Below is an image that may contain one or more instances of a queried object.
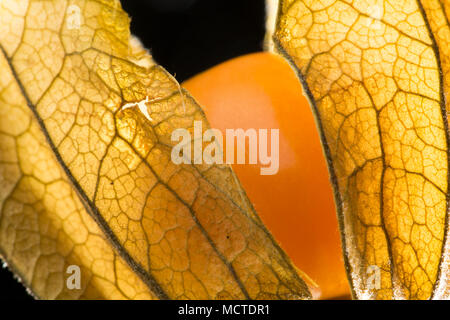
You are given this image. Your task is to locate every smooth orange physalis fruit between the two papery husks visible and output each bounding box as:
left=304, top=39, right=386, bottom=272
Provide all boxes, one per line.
left=182, top=53, right=350, bottom=299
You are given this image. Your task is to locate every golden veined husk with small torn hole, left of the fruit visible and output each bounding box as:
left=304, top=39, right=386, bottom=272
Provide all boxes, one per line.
left=0, top=0, right=310, bottom=299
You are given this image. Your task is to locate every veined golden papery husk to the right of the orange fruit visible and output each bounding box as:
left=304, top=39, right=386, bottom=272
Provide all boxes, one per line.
left=273, top=0, right=449, bottom=299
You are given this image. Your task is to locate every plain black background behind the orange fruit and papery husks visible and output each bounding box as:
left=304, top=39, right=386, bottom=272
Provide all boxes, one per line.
left=0, top=0, right=265, bottom=299
